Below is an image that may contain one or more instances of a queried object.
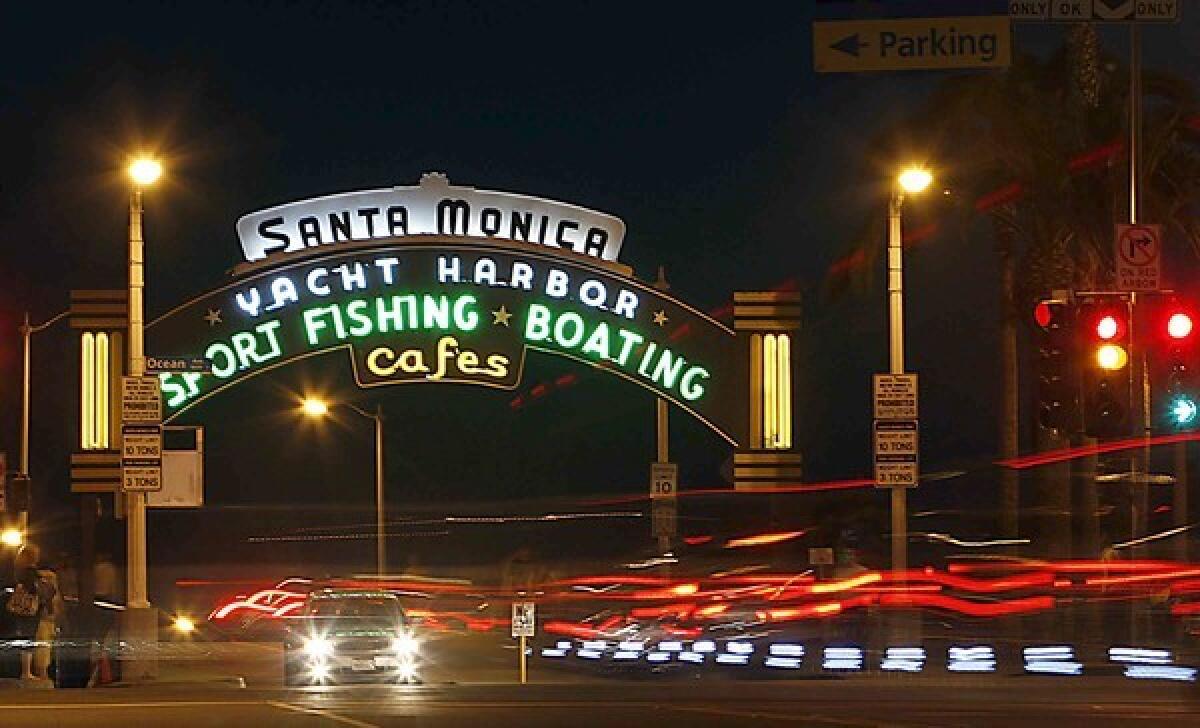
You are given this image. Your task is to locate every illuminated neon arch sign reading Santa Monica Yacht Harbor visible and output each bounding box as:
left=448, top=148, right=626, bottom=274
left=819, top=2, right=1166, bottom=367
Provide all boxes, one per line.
left=146, top=175, right=748, bottom=445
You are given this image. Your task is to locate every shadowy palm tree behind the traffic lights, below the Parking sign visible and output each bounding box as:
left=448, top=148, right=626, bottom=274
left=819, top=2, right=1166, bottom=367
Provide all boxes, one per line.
left=827, top=25, right=1200, bottom=555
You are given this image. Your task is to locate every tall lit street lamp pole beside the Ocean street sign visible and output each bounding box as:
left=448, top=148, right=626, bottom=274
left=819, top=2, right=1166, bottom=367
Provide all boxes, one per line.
left=125, top=158, right=162, bottom=609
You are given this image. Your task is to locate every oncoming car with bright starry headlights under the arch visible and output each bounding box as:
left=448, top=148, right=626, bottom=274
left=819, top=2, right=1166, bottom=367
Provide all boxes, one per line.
left=283, top=589, right=420, bottom=686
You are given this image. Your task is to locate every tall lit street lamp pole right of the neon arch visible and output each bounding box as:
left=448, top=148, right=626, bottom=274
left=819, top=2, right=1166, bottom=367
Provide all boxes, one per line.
left=888, top=167, right=934, bottom=571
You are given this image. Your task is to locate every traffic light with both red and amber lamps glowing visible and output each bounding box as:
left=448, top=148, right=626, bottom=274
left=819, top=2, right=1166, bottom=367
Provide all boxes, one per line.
left=1076, top=299, right=1133, bottom=438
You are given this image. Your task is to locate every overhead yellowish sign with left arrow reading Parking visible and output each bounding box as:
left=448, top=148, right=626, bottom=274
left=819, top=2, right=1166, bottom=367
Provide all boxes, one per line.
left=812, top=16, right=1013, bottom=73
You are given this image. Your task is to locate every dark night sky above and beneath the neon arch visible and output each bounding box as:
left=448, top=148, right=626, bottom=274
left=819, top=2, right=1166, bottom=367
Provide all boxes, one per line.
left=0, top=1, right=1200, bottom=570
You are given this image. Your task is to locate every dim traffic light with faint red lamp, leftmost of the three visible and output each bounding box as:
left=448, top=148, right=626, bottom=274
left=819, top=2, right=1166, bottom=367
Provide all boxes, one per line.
left=1033, top=300, right=1079, bottom=433
